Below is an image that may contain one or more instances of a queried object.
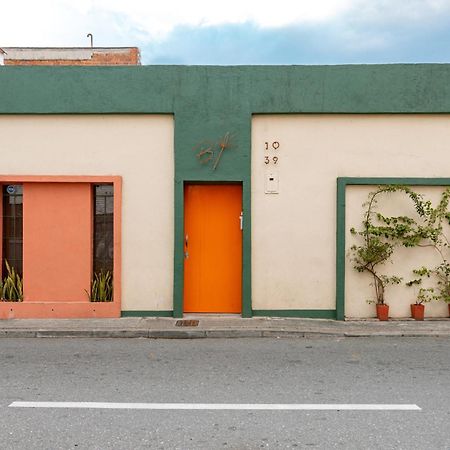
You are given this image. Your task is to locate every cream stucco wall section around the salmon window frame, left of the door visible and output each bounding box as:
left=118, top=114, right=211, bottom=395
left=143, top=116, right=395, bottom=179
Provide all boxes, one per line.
left=0, top=115, right=174, bottom=310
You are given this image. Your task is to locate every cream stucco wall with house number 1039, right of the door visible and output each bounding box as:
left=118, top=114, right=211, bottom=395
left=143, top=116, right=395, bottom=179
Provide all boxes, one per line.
left=252, top=115, right=450, bottom=317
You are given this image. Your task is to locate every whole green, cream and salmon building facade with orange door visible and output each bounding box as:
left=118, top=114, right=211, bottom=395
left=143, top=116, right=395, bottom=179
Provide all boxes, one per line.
left=0, top=65, right=450, bottom=319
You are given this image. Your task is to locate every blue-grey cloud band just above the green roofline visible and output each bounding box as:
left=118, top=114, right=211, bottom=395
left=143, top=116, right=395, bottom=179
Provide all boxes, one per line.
left=142, top=11, right=450, bottom=65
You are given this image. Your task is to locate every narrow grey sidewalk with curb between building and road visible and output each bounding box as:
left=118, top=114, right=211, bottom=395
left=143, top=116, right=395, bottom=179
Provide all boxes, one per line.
left=0, top=315, right=450, bottom=339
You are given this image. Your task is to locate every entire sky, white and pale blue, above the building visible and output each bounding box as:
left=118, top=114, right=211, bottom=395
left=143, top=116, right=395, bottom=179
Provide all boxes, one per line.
left=0, top=0, right=450, bottom=64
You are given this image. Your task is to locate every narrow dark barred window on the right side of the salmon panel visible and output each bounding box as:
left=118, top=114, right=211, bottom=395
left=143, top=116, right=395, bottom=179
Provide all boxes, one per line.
left=93, top=184, right=114, bottom=273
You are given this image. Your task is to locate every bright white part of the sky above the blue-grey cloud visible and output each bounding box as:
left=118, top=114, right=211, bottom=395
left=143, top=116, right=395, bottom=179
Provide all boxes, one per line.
left=0, top=0, right=374, bottom=46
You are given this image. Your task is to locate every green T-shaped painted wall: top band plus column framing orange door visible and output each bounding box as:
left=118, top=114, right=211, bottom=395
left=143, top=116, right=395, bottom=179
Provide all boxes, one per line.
left=0, top=64, right=450, bottom=318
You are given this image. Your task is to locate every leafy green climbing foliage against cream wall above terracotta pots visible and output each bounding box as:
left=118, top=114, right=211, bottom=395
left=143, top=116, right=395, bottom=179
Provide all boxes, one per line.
left=350, top=185, right=450, bottom=303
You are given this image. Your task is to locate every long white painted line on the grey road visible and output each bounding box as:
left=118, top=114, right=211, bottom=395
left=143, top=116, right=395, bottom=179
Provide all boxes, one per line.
left=9, top=402, right=422, bottom=411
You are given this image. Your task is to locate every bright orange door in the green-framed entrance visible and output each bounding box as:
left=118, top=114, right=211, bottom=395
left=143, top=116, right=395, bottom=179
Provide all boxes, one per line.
left=184, top=184, right=242, bottom=313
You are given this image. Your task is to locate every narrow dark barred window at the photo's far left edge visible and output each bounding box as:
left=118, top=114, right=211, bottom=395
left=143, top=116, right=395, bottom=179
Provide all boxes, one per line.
left=2, top=184, right=23, bottom=277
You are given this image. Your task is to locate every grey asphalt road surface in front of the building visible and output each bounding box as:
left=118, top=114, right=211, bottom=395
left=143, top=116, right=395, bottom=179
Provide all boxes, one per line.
left=0, top=337, right=450, bottom=449
